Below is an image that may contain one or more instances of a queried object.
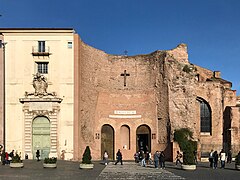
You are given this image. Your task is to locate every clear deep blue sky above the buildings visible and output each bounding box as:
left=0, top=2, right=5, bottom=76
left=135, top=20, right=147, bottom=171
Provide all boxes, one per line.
left=0, top=0, right=240, bottom=95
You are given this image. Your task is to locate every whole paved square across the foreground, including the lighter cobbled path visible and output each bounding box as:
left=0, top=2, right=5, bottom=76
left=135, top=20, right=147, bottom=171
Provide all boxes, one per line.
left=0, top=160, right=240, bottom=180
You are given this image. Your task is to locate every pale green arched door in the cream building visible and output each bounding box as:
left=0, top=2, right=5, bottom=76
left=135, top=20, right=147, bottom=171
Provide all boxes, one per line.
left=32, top=116, right=51, bottom=159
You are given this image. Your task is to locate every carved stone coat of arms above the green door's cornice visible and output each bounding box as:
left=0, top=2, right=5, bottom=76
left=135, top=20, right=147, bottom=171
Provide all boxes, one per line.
left=25, top=73, right=57, bottom=98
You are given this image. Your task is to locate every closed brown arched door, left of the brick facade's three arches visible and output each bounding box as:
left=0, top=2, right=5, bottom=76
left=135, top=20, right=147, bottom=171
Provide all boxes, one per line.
left=101, top=124, right=114, bottom=160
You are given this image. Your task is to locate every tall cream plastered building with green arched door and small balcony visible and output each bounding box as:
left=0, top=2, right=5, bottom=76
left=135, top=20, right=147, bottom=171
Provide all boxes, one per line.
left=0, top=28, right=75, bottom=159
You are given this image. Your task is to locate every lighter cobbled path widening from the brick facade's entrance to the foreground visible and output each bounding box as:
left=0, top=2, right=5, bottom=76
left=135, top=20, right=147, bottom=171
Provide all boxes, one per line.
left=97, top=162, right=185, bottom=180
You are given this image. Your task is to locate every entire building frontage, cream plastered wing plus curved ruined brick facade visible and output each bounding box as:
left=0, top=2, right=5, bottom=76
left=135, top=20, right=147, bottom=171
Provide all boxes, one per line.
left=0, top=29, right=240, bottom=160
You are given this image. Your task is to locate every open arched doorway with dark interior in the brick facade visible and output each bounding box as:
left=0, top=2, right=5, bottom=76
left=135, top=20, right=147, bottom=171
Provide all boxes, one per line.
left=136, top=125, right=151, bottom=152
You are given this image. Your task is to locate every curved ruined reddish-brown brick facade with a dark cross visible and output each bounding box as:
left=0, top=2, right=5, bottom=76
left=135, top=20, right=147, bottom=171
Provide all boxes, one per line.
left=76, top=40, right=239, bottom=159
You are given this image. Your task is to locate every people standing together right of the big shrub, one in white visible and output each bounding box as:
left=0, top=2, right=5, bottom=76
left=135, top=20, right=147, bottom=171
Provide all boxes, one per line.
left=209, top=149, right=232, bottom=169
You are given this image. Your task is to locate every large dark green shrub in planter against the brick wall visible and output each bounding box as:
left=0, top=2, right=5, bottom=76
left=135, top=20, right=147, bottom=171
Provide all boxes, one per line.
left=174, top=128, right=197, bottom=165
